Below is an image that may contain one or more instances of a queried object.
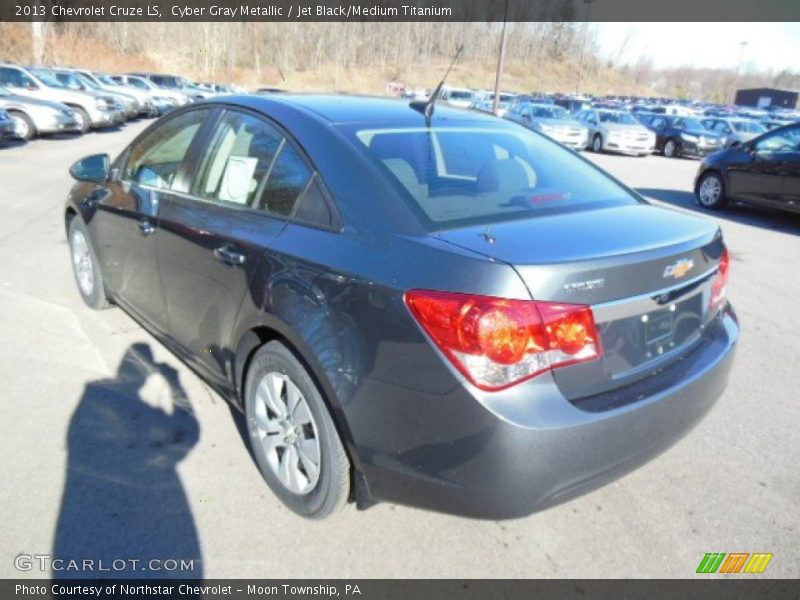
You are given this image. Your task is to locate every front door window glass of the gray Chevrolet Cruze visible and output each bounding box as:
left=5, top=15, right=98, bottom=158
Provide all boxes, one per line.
left=122, top=110, right=209, bottom=189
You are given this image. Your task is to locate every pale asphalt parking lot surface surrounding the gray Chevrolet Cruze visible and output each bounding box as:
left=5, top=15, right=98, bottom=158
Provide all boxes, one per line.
left=0, top=122, right=800, bottom=578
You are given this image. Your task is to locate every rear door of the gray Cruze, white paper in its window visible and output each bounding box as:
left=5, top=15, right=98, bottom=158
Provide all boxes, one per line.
left=159, top=110, right=330, bottom=387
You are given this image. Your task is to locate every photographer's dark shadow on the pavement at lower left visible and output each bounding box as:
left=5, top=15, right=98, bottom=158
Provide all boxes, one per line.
left=52, top=343, right=203, bottom=580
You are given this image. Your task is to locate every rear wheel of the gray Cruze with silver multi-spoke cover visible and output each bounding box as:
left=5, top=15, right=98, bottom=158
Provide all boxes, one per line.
left=245, top=341, right=350, bottom=519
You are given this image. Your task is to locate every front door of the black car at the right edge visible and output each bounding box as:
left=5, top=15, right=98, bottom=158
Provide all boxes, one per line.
left=728, top=126, right=792, bottom=205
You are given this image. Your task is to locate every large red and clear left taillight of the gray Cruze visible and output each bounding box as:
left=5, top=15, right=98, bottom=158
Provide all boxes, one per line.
left=405, top=290, right=602, bottom=390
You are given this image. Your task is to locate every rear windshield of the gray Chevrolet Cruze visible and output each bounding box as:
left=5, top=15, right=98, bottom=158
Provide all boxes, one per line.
left=349, top=125, right=639, bottom=230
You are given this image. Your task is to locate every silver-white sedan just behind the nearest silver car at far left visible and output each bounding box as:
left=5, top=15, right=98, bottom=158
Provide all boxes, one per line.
left=0, top=63, right=122, bottom=133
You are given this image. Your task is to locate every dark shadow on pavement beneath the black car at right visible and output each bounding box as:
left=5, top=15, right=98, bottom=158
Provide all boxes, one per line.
left=636, top=188, right=800, bottom=235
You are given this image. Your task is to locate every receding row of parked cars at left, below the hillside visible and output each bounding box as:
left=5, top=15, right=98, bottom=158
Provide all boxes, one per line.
left=0, top=63, right=242, bottom=140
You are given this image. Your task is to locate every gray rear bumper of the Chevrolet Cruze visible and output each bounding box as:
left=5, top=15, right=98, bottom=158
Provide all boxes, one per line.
left=356, top=307, right=739, bottom=519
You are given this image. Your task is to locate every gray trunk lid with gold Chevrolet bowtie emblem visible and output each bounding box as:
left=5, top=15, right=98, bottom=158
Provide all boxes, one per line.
left=438, top=204, right=724, bottom=399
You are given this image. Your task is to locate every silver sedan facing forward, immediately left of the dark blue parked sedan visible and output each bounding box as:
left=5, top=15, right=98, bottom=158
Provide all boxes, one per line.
left=577, top=108, right=656, bottom=156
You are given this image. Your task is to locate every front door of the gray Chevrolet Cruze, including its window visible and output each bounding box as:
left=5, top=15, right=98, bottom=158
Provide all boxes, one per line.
left=90, top=110, right=211, bottom=333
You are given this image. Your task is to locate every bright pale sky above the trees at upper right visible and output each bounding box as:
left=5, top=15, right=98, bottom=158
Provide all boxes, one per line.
left=589, top=23, right=800, bottom=71
